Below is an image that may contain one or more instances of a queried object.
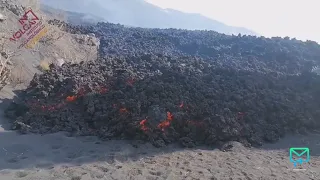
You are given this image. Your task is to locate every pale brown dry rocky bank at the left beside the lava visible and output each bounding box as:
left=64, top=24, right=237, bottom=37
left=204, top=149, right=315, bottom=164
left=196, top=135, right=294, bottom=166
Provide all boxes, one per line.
left=0, top=0, right=97, bottom=85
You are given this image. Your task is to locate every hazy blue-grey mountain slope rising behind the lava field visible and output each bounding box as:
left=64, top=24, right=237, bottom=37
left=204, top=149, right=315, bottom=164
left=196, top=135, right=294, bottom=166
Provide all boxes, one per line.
left=41, top=0, right=258, bottom=35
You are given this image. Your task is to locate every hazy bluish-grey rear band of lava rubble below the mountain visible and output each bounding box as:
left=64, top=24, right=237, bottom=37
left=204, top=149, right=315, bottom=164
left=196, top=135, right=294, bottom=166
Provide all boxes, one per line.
left=82, top=23, right=320, bottom=74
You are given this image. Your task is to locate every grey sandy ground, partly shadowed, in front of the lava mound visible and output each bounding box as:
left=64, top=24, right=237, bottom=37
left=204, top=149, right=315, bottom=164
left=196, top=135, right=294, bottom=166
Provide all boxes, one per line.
left=0, top=88, right=320, bottom=180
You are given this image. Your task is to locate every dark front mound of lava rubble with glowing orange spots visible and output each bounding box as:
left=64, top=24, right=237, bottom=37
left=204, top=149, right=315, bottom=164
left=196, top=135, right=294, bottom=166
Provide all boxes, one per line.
left=6, top=55, right=320, bottom=147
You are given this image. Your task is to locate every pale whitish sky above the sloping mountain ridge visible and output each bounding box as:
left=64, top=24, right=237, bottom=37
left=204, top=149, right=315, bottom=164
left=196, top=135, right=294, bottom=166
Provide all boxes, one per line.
left=146, top=0, right=320, bottom=42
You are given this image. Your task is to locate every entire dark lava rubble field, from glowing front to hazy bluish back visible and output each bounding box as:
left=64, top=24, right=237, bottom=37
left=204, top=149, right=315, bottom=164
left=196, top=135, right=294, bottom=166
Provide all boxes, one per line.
left=6, top=22, right=320, bottom=146
